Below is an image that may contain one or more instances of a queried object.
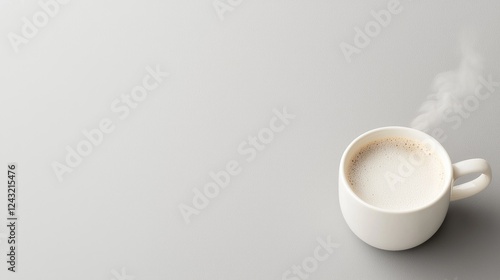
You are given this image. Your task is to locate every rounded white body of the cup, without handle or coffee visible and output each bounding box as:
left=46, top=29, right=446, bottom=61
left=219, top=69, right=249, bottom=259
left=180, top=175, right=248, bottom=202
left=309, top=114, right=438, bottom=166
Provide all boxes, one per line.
left=339, top=127, right=453, bottom=250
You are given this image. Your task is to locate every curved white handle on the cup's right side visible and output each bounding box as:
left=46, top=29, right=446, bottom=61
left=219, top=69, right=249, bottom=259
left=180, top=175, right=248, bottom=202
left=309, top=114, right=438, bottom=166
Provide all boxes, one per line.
left=450, top=158, right=491, bottom=201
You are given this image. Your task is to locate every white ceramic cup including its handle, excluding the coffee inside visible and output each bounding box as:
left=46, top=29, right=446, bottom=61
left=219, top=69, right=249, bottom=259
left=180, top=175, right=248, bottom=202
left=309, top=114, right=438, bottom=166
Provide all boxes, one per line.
left=339, top=127, right=491, bottom=250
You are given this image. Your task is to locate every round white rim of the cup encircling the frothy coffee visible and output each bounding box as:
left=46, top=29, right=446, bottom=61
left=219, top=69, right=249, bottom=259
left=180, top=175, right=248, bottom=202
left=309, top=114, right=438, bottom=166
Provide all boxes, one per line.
left=339, top=126, right=453, bottom=214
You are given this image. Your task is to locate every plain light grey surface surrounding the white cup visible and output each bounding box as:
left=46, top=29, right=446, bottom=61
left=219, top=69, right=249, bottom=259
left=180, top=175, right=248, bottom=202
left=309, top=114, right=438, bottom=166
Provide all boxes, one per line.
left=0, top=0, right=500, bottom=280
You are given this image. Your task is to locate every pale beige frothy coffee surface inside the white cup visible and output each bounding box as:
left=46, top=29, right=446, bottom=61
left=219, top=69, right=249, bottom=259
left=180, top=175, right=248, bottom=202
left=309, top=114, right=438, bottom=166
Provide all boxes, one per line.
left=346, top=137, right=445, bottom=210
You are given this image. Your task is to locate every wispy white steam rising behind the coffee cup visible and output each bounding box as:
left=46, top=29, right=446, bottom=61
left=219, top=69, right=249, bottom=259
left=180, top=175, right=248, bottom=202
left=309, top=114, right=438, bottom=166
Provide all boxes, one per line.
left=411, top=32, right=483, bottom=131
